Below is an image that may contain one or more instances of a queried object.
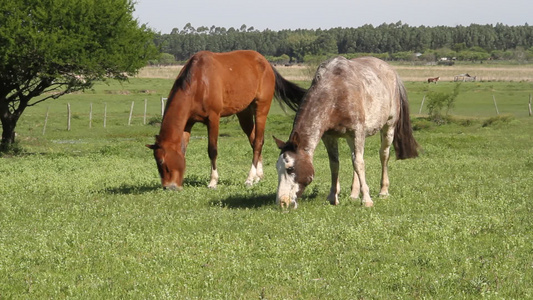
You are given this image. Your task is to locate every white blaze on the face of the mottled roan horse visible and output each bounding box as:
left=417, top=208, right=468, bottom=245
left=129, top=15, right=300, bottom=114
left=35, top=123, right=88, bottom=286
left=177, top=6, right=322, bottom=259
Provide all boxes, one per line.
left=276, top=152, right=299, bottom=208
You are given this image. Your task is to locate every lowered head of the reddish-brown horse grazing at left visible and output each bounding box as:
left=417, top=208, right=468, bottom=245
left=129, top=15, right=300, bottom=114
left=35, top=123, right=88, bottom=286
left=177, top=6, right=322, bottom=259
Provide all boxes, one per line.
left=146, top=136, right=185, bottom=190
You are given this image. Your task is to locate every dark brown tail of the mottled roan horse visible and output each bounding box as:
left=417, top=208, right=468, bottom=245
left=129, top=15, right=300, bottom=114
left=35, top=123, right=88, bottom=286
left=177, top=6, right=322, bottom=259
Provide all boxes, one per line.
left=393, top=77, right=419, bottom=159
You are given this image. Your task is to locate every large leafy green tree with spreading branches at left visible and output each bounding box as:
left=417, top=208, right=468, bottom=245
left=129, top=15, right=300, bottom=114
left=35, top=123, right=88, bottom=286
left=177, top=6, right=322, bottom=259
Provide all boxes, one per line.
left=0, top=0, right=157, bottom=150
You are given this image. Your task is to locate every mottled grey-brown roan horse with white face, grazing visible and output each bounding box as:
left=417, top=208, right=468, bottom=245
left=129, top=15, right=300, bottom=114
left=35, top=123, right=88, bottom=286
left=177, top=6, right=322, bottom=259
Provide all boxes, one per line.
left=274, top=57, right=418, bottom=207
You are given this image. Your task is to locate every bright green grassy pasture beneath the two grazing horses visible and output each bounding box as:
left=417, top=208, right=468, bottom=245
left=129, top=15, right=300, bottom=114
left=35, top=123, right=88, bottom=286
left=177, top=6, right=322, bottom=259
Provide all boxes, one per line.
left=0, top=67, right=533, bottom=299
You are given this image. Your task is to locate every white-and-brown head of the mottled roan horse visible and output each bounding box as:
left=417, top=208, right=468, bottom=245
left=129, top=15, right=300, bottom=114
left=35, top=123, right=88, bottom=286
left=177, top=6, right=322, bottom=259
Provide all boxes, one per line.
left=274, top=137, right=315, bottom=208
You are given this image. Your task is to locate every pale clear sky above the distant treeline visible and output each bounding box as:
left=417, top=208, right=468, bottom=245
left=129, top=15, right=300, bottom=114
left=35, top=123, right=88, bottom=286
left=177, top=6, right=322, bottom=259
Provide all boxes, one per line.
left=134, top=0, right=533, bottom=33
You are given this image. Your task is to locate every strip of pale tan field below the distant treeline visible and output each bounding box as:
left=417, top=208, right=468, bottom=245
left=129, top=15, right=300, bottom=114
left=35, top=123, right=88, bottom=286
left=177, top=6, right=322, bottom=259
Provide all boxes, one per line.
left=137, top=63, right=533, bottom=81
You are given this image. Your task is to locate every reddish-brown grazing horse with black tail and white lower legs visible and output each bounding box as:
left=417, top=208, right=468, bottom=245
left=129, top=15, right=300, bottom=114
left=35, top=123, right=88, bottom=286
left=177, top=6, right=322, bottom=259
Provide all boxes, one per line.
left=146, top=51, right=306, bottom=190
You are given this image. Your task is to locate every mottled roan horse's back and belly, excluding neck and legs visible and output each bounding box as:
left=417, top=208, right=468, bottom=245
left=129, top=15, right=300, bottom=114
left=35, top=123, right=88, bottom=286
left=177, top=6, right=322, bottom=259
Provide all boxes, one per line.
left=315, top=57, right=399, bottom=135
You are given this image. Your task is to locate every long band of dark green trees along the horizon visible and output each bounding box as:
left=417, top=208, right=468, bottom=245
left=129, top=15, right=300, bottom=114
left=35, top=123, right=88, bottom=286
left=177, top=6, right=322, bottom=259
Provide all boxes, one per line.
left=153, top=21, right=533, bottom=64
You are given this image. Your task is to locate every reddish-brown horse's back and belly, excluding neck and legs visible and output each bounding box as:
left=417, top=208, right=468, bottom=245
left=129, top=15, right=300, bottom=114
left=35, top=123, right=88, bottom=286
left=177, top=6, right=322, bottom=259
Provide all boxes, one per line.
left=169, top=50, right=275, bottom=119
